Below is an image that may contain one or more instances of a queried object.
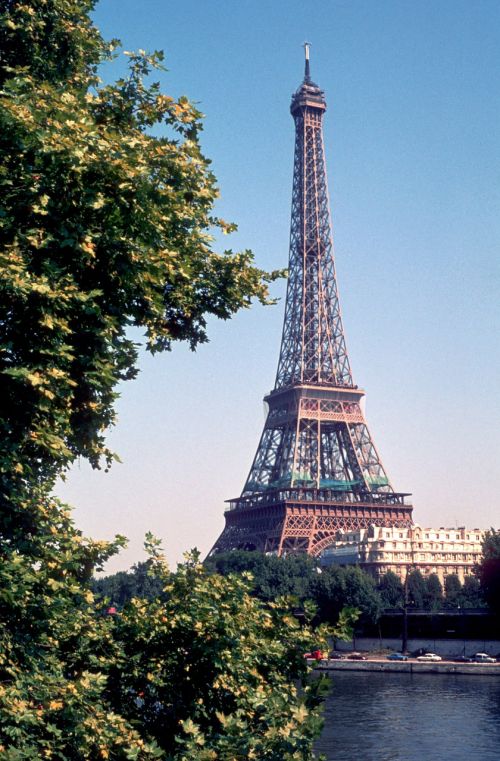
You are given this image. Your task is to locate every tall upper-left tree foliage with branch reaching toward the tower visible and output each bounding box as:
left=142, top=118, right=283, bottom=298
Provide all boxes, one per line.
left=0, top=0, right=275, bottom=497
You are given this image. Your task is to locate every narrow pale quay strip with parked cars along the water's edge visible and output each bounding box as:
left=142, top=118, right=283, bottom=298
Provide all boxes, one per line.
left=316, top=658, right=500, bottom=677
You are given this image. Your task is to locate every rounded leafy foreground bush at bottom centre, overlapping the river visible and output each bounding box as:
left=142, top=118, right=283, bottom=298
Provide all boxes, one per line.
left=109, top=555, right=345, bottom=761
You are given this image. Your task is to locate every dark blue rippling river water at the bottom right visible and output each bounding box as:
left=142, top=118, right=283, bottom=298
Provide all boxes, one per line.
left=316, top=671, right=500, bottom=761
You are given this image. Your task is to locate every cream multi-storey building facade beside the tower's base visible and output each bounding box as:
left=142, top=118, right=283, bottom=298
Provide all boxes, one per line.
left=321, top=524, right=486, bottom=584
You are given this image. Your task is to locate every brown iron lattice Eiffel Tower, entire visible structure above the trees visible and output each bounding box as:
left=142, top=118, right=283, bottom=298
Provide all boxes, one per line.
left=211, top=49, right=412, bottom=555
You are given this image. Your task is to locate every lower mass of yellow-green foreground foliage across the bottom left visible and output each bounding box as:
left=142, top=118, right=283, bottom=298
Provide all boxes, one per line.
left=0, top=520, right=349, bottom=761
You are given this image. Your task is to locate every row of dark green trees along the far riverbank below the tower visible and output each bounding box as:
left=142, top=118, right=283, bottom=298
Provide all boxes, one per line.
left=94, top=548, right=500, bottom=637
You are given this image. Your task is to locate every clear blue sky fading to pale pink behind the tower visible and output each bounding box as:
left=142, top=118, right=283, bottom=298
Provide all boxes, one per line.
left=59, top=0, right=500, bottom=571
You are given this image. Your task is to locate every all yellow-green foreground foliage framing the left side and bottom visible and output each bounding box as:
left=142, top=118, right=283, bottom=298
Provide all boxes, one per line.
left=0, top=0, right=336, bottom=761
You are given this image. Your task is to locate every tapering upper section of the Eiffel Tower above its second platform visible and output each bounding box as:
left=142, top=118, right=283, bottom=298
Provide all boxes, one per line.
left=276, top=42, right=353, bottom=388
